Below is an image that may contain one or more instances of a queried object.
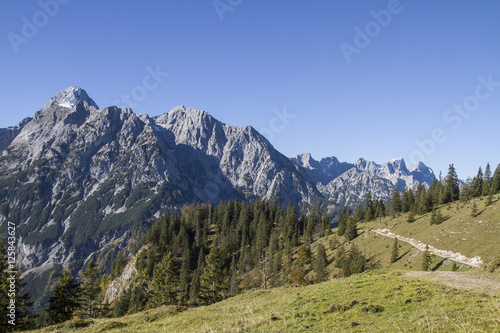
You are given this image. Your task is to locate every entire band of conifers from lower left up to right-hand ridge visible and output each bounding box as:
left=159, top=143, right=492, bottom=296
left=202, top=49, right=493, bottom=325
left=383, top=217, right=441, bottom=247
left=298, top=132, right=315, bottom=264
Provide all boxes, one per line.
left=12, top=164, right=500, bottom=324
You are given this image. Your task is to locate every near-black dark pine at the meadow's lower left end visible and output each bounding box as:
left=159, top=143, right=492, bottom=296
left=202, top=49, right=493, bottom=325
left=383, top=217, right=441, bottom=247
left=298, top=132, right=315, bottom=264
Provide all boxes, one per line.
left=45, top=271, right=80, bottom=325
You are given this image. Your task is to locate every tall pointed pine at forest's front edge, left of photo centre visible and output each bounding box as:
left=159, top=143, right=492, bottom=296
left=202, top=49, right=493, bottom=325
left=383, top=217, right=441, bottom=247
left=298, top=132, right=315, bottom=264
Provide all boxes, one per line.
left=200, top=242, right=226, bottom=304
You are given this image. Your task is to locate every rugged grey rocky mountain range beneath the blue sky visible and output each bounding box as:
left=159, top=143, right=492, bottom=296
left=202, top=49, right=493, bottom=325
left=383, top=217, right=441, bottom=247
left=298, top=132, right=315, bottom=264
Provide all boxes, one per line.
left=0, top=87, right=434, bottom=306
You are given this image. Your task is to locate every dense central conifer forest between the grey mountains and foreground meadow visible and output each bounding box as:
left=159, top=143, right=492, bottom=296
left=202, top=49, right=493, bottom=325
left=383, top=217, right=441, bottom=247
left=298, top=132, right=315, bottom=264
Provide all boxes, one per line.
left=110, top=200, right=371, bottom=316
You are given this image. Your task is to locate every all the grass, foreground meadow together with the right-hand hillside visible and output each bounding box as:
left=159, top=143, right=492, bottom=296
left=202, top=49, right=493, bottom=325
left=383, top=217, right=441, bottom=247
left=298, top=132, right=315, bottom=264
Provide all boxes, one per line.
left=32, top=197, right=500, bottom=333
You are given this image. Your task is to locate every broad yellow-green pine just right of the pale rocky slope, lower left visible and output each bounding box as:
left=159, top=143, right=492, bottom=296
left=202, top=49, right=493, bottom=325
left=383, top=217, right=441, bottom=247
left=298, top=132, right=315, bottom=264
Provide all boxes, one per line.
left=149, top=252, right=179, bottom=307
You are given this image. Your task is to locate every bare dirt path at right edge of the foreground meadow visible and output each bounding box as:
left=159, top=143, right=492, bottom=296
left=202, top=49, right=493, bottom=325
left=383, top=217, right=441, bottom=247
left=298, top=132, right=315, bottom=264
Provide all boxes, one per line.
left=405, top=271, right=500, bottom=295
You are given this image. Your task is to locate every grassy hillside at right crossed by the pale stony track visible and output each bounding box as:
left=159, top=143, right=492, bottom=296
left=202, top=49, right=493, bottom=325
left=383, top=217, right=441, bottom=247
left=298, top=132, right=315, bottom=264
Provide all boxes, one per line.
left=342, top=192, right=500, bottom=271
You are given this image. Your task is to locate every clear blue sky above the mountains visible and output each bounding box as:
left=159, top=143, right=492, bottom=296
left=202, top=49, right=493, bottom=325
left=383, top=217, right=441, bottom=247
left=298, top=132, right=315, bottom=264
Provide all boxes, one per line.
left=0, top=0, right=500, bottom=178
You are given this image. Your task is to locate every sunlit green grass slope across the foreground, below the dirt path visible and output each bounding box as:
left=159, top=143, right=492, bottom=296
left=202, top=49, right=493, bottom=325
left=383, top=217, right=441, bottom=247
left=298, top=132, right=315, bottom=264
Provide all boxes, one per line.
left=31, top=270, right=500, bottom=333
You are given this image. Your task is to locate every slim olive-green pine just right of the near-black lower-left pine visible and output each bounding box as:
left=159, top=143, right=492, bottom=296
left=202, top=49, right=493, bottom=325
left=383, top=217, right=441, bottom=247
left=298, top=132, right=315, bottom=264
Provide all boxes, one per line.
left=78, top=260, right=101, bottom=319
